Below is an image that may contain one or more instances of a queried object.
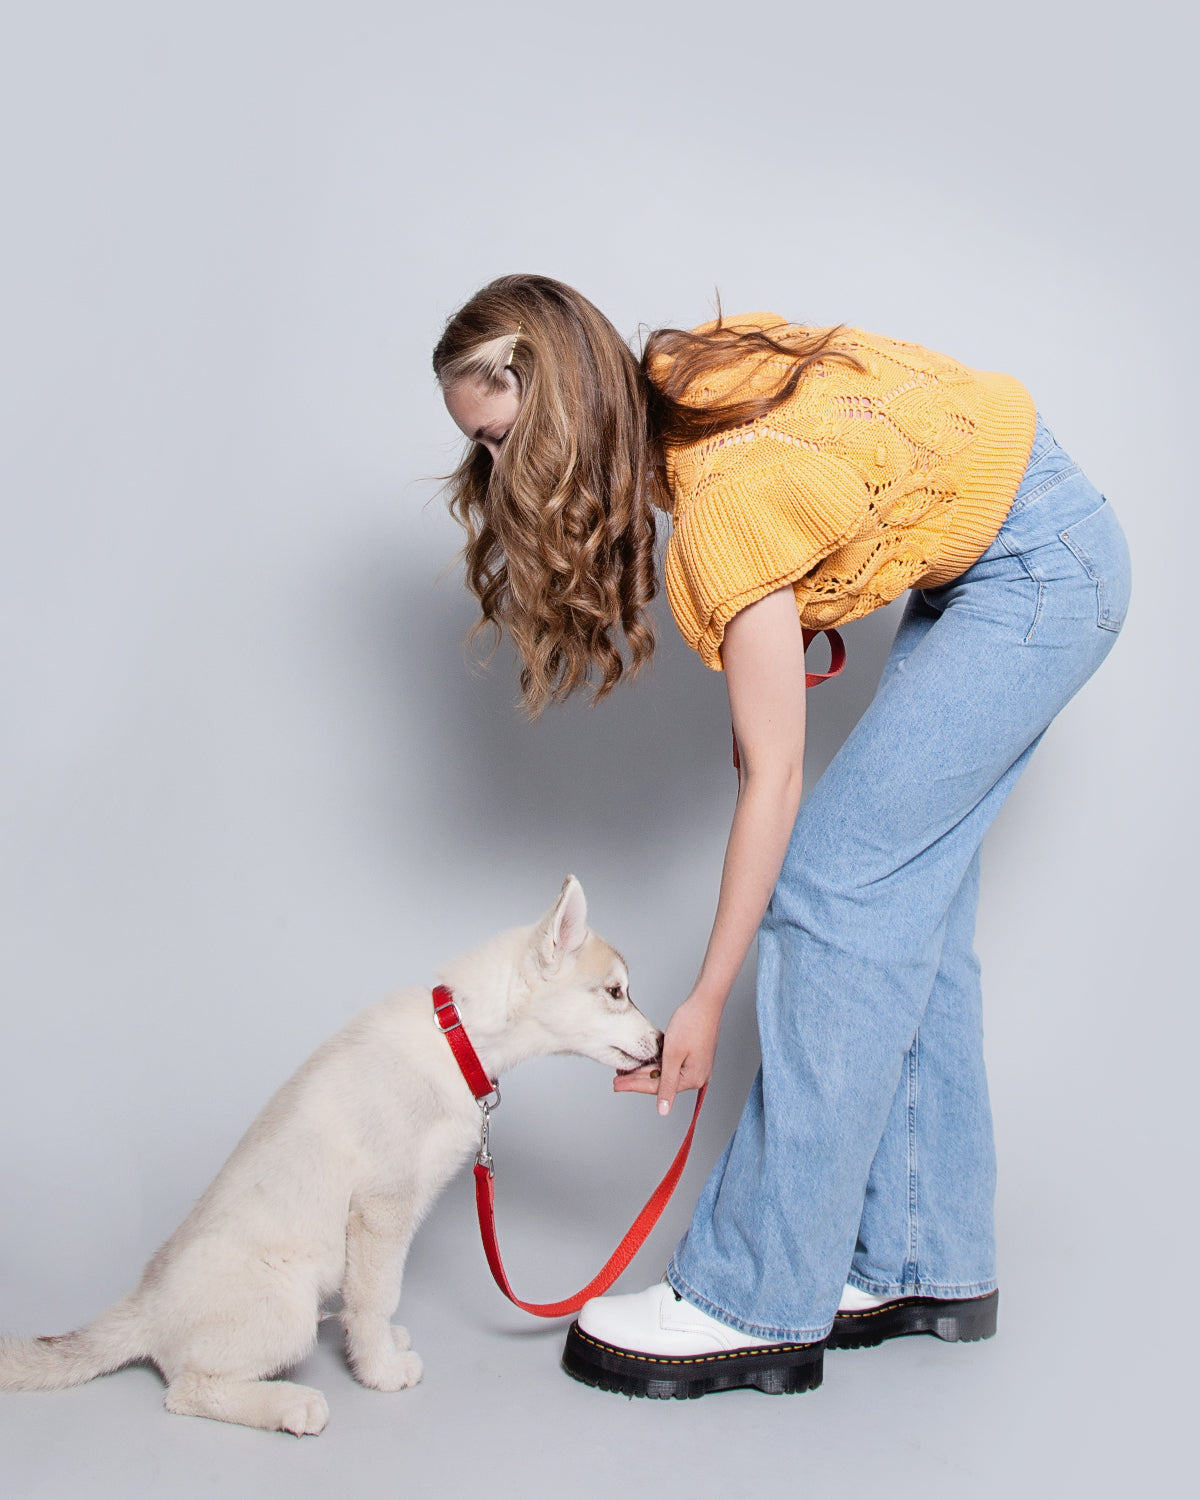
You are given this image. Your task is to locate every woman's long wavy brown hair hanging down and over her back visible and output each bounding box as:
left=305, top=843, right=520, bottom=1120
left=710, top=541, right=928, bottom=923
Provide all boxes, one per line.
left=434, top=276, right=854, bottom=717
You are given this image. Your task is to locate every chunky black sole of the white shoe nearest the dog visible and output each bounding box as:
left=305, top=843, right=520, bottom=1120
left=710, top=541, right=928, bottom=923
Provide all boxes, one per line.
left=563, top=1323, right=825, bottom=1401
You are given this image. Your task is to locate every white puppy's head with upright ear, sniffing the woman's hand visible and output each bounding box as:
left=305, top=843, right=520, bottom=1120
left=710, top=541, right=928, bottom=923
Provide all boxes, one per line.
left=518, top=875, right=663, bottom=1073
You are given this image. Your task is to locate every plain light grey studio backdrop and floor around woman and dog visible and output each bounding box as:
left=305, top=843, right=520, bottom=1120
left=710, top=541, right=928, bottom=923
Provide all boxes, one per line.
left=0, top=0, right=1197, bottom=1500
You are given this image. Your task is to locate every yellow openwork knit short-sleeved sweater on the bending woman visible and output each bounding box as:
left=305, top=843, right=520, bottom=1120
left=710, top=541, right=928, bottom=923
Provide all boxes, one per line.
left=666, top=314, right=1035, bottom=671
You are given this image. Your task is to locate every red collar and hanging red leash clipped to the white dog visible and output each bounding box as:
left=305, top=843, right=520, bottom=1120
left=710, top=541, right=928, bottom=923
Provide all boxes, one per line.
left=434, top=984, right=705, bottom=1317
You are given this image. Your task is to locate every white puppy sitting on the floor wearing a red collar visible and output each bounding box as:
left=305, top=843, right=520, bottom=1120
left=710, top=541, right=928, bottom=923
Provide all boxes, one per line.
left=0, top=876, right=662, bottom=1436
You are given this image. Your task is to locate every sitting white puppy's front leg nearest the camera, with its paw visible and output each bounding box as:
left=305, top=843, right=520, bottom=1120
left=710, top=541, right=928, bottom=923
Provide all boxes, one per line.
left=342, top=1194, right=422, bottom=1391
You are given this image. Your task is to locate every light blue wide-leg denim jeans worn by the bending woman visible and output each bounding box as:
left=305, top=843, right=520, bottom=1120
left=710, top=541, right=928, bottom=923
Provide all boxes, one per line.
left=668, top=420, right=1130, bottom=1341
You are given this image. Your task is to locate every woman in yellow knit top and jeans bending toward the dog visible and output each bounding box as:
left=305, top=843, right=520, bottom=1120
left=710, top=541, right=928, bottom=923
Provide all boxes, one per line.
left=434, top=276, right=1128, bottom=1395
